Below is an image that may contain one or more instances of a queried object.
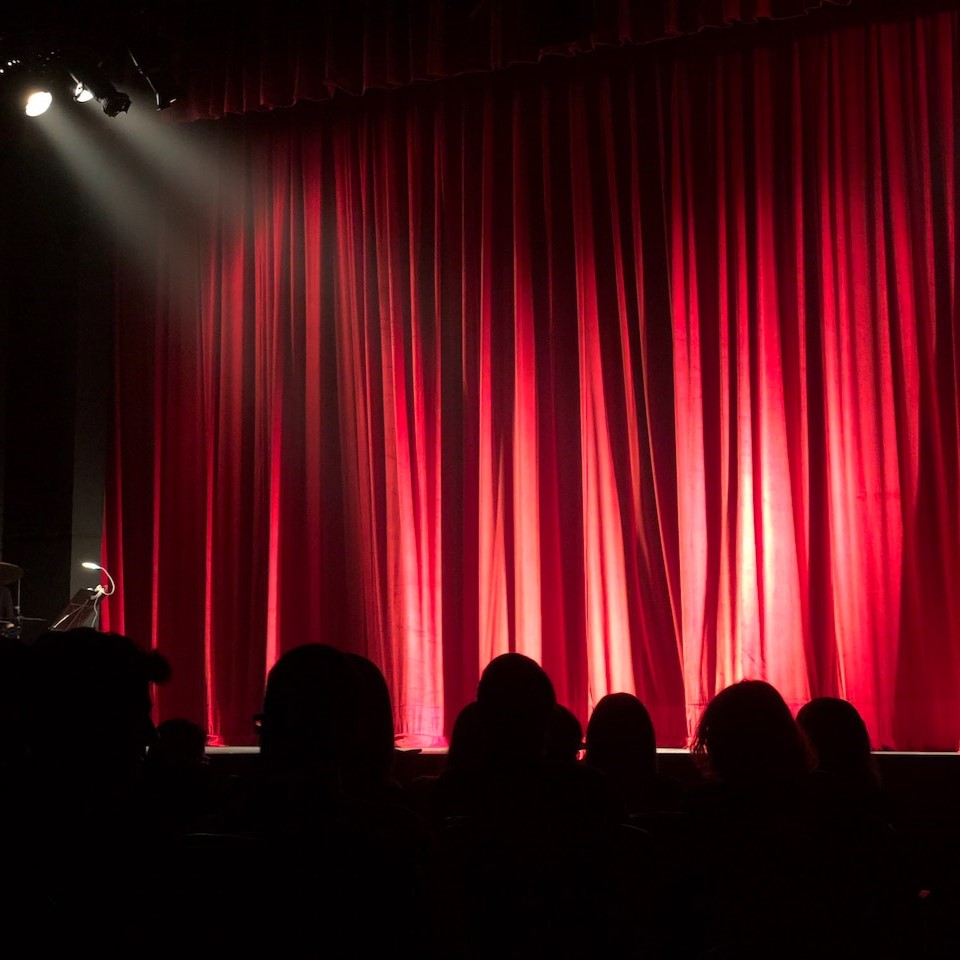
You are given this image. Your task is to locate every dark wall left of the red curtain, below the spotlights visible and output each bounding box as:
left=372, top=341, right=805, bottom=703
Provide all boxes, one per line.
left=0, top=104, right=111, bottom=638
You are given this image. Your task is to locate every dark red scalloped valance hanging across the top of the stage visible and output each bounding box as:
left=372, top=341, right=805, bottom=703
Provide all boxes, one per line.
left=167, top=0, right=848, bottom=119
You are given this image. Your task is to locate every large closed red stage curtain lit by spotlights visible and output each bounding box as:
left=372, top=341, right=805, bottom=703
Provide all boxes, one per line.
left=104, top=5, right=960, bottom=749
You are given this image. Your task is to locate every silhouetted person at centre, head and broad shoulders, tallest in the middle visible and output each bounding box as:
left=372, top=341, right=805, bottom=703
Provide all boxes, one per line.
left=440, top=653, right=649, bottom=956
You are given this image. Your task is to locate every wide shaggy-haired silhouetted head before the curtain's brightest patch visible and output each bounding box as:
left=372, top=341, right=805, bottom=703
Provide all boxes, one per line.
left=693, top=680, right=808, bottom=782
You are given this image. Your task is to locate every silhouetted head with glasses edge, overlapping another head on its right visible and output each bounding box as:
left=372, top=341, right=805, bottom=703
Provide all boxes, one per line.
left=260, top=643, right=358, bottom=776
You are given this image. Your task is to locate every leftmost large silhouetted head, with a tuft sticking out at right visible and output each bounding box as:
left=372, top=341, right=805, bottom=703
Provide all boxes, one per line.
left=30, top=627, right=170, bottom=767
